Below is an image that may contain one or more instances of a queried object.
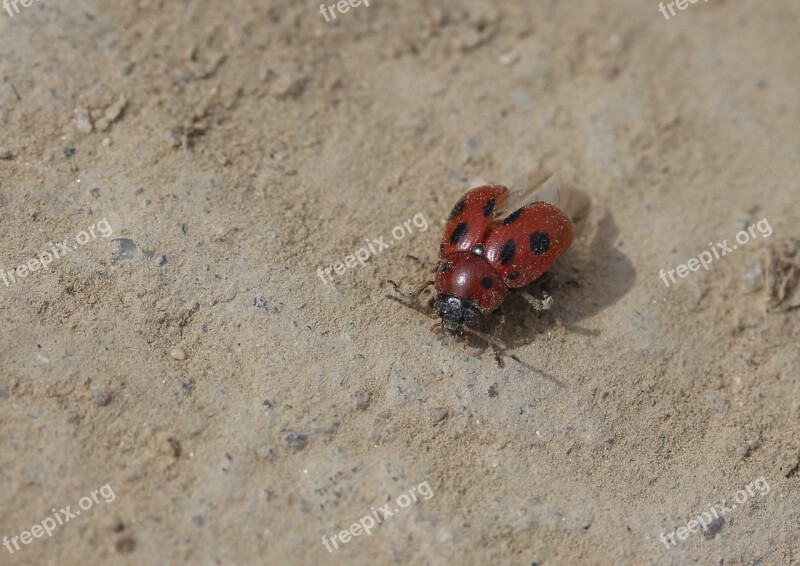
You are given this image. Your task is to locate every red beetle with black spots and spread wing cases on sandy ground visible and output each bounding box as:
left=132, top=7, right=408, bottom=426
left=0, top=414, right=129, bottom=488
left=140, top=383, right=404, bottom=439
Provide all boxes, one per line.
left=386, top=173, right=574, bottom=366
